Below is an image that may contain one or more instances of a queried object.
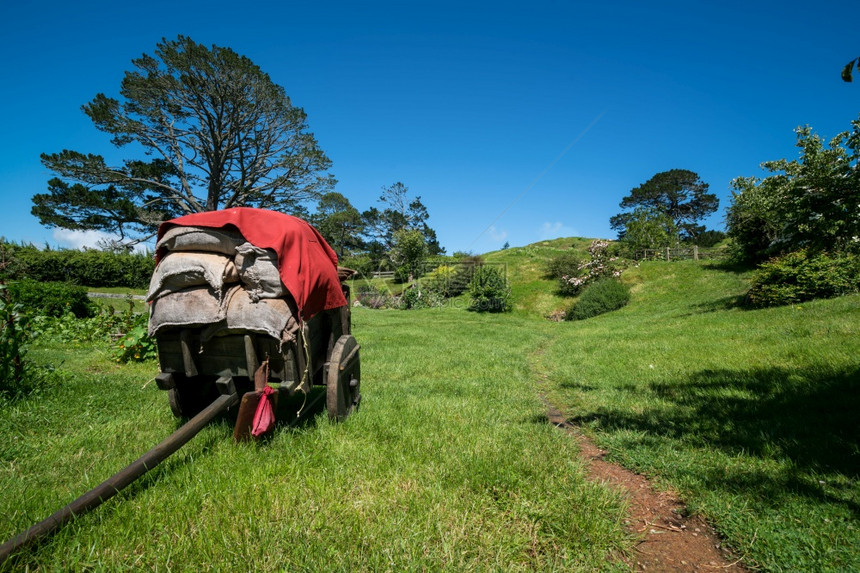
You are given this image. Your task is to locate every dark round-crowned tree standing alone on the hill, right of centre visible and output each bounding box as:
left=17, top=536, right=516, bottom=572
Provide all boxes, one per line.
left=609, top=169, right=720, bottom=241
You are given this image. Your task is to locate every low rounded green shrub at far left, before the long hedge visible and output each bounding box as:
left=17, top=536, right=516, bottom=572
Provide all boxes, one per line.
left=8, top=279, right=95, bottom=318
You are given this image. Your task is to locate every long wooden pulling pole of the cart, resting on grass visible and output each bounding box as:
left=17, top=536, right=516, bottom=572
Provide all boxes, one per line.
left=0, top=394, right=239, bottom=564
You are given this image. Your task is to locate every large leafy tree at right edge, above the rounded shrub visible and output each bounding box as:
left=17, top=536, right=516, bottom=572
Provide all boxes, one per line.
left=726, top=119, right=860, bottom=262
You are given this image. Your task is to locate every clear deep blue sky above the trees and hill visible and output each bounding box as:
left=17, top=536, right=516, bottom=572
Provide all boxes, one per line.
left=0, top=0, right=860, bottom=253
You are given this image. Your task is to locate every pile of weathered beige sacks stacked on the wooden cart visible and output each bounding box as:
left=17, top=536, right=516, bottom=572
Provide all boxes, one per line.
left=151, top=226, right=299, bottom=343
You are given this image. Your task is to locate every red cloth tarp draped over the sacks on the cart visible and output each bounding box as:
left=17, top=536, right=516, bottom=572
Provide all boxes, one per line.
left=156, top=207, right=347, bottom=320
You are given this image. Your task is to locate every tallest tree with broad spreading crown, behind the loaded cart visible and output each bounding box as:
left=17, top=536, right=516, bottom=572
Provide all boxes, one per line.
left=32, top=36, right=335, bottom=243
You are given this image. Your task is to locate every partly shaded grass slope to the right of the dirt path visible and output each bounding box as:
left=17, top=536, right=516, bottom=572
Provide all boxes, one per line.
left=540, top=263, right=860, bottom=571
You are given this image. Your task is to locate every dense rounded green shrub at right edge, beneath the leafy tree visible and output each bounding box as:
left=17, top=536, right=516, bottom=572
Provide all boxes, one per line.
left=747, top=249, right=860, bottom=308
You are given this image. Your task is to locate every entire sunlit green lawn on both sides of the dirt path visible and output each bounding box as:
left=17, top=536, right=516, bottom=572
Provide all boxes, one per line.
left=0, top=244, right=860, bottom=571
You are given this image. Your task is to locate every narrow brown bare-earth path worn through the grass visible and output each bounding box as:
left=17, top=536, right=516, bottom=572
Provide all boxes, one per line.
left=544, top=400, right=747, bottom=572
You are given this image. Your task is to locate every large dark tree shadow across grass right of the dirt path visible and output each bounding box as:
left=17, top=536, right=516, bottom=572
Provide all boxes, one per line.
left=571, top=365, right=860, bottom=512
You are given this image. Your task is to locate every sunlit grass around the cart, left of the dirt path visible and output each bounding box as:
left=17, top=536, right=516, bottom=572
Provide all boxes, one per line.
left=0, top=309, right=630, bottom=571
